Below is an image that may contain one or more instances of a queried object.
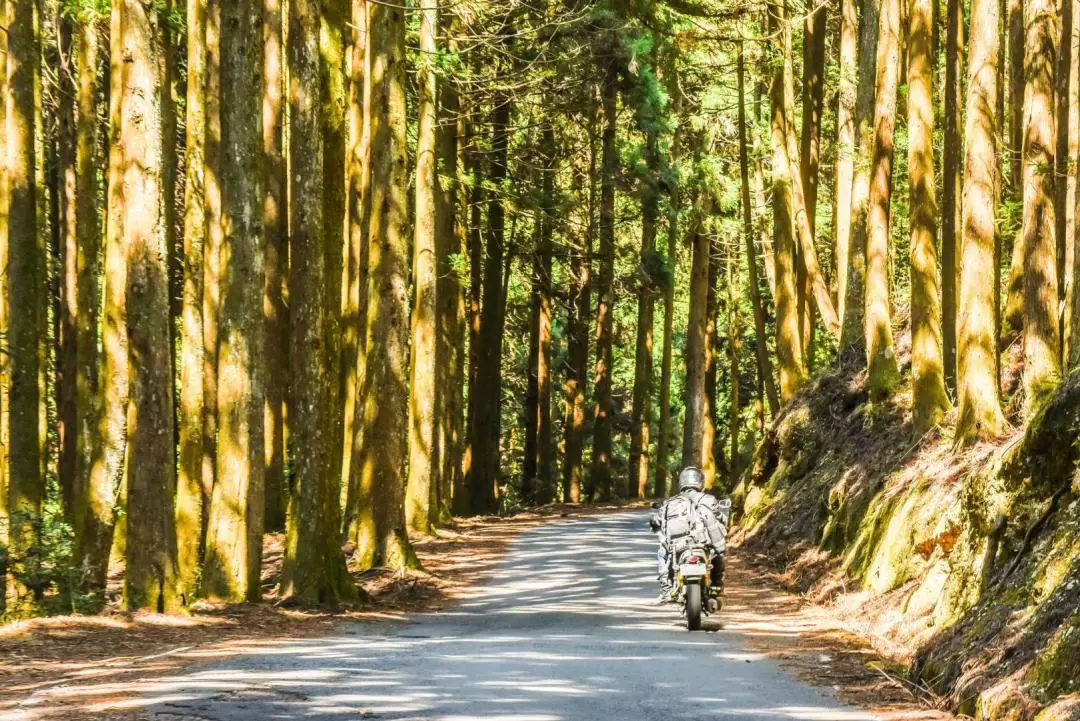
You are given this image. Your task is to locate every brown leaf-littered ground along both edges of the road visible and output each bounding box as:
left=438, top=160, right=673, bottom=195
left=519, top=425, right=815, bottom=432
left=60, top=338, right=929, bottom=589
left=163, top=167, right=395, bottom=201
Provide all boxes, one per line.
left=0, top=506, right=951, bottom=721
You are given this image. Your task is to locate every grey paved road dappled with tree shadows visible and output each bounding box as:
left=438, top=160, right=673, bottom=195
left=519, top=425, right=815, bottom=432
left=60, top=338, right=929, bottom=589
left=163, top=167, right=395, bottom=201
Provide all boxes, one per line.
left=140, top=512, right=872, bottom=721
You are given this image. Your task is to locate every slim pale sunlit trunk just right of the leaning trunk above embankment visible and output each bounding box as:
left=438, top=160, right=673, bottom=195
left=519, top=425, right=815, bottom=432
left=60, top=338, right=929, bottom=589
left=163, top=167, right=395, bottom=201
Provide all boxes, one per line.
left=833, top=0, right=859, bottom=338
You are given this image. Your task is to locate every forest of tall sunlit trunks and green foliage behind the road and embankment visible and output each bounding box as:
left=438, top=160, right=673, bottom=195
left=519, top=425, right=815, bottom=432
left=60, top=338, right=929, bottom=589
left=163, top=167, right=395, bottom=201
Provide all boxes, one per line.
left=0, top=0, right=1080, bottom=617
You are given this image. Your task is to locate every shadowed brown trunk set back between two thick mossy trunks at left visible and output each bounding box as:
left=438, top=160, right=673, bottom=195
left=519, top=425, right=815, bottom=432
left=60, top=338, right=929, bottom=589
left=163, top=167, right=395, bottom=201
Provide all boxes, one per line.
left=263, top=0, right=288, bottom=531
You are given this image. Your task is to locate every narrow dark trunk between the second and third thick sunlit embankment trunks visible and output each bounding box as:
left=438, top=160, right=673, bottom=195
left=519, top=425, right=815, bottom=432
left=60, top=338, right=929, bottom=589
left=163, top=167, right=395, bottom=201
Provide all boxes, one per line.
left=942, top=0, right=963, bottom=385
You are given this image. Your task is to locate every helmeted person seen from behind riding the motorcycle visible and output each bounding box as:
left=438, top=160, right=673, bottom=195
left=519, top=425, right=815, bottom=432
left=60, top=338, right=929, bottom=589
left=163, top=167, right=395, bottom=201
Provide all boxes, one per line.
left=649, top=466, right=731, bottom=601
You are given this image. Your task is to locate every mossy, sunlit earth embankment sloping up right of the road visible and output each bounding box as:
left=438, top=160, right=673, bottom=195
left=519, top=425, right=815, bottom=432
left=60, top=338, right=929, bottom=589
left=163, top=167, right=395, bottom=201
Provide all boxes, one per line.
left=735, top=345, right=1080, bottom=721
